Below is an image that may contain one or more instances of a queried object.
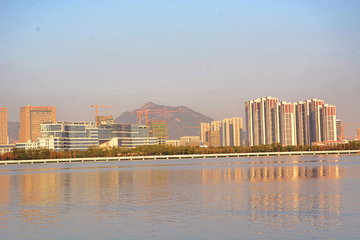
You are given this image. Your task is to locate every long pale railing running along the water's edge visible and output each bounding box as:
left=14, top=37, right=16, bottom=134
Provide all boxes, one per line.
left=0, top=150, right=360, bottom=165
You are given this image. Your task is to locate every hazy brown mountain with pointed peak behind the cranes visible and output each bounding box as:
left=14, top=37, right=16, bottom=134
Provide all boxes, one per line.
left=115, top=102, right=213, bottom=140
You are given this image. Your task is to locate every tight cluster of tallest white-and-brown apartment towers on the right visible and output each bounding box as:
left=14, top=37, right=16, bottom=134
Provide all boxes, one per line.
left=245, top=97, right=337, bottom=146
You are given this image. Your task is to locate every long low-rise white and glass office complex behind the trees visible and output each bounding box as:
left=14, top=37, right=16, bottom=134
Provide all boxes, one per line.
left=16, top=122, right=158, bottom=151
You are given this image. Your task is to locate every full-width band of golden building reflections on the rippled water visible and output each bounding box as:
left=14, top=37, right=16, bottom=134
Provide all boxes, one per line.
left=0, top=163, right=345, bottom=236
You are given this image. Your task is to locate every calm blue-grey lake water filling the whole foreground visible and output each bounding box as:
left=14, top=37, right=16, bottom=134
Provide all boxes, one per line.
left=0, top=155, right=360, bottom=239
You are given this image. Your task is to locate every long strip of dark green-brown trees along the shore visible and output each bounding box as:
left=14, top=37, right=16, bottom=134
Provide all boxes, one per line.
left=0, top=140, right=360, bottom=161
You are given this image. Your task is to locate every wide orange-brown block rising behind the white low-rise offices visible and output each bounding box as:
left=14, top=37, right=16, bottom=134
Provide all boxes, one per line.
left=19, top=106, right=56, bottom=142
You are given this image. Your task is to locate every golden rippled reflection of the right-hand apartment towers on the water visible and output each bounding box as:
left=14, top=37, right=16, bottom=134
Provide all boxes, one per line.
left=202, top=165, right=345, bottom=235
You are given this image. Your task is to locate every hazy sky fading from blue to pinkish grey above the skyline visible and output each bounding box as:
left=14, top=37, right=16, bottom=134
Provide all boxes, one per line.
left=0, top=0, right=360, bottom=135
